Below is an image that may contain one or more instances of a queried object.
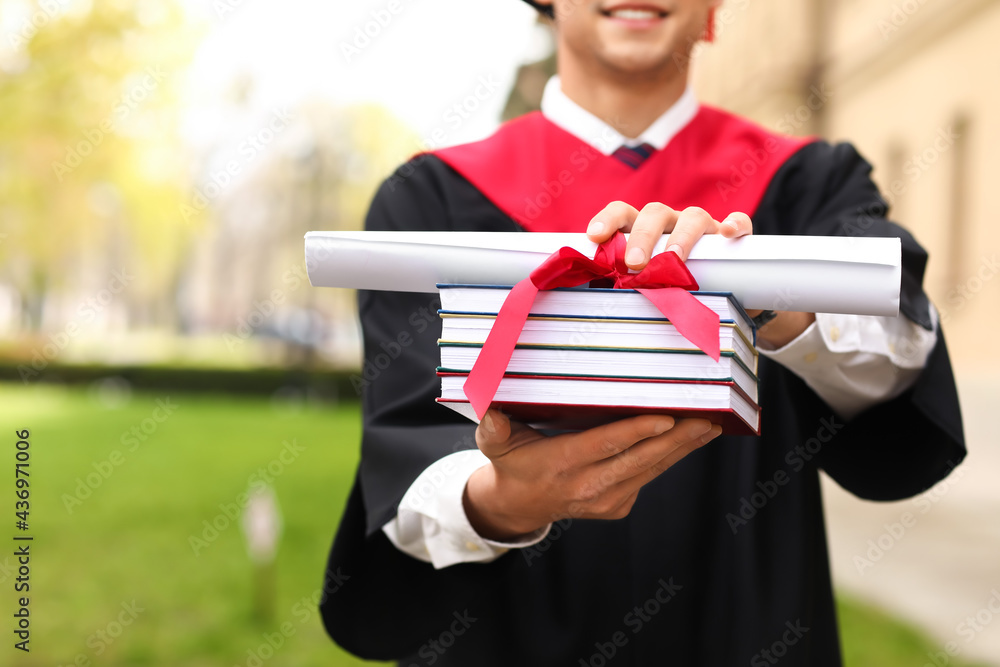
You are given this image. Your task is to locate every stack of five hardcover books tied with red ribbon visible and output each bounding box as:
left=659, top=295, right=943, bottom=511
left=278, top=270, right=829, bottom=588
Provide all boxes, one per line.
left=438, top=285, right=760, bottom=435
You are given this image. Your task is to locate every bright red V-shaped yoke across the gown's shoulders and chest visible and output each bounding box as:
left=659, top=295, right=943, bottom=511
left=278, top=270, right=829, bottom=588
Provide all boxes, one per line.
left=435, top=106, right=813, bottom=232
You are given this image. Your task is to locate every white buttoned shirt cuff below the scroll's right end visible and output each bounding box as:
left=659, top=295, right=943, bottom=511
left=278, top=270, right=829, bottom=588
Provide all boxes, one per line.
left=758, top=307, right=937, bottom=419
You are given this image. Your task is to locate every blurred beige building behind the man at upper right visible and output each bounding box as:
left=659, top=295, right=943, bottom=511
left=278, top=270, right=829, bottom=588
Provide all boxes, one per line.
left=695, top=0, right=1000, bottom=370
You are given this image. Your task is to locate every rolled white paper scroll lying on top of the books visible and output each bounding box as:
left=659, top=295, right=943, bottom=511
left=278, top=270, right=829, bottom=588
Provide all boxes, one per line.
left=305, top=232, right=901, bottom=316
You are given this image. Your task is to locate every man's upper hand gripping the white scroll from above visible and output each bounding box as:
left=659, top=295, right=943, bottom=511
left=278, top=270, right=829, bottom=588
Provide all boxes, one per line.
left=587, top=201, right=816, bottom=348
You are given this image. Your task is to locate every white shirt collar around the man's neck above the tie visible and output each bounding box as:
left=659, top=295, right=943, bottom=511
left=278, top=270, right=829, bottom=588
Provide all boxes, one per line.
left=542, top=75, right=698, bottom=155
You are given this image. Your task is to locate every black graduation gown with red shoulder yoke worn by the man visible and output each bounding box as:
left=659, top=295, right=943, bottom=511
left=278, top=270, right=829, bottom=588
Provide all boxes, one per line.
left=320, top=107, right=965, bottom=666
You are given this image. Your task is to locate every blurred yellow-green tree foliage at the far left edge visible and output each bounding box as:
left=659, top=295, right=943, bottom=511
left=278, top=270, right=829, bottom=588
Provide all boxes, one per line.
left=0, top=2, right=197, bottom=331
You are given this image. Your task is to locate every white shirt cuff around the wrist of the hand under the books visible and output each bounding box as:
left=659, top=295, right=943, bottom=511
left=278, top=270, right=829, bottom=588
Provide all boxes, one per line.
left=382, top=449, right=552, bottom=569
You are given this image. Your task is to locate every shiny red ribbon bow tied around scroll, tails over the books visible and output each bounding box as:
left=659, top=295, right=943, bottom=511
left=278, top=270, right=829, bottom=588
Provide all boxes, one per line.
left=464, top=232, right=719, bottom=419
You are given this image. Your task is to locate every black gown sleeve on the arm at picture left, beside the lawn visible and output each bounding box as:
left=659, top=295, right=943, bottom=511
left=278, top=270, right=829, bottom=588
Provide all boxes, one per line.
left=320, top=156, right=519, bottom=659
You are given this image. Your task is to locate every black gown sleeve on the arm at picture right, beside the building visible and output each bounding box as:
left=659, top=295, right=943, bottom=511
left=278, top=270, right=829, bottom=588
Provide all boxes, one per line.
left=754, top=142, right=965, bottom=500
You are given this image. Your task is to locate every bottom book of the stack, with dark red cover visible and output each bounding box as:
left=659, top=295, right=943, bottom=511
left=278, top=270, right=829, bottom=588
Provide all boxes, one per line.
left=437, top=371, right=760, bottom=435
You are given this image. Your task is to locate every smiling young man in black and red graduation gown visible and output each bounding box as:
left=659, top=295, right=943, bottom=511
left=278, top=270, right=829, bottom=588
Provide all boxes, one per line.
left=321, top=0, right=965, bottom=665
